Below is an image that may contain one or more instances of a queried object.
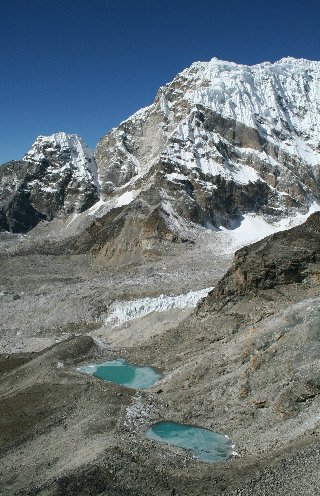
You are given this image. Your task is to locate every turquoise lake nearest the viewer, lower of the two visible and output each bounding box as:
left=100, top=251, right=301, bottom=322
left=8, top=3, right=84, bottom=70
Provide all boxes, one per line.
left=145, top=422, right=232, bottom=463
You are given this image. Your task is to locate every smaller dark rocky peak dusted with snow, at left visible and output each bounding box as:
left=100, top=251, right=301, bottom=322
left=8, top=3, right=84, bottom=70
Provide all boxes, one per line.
left=0, top=132, right=99, bottom=232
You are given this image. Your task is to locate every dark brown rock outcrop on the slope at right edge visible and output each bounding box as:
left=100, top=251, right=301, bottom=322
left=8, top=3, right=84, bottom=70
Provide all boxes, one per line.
left=198, top=212, right=320, bottom=313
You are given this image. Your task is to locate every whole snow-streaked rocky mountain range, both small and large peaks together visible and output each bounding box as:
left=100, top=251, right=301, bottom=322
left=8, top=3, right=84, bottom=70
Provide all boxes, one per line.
left=0, top=58, right=320, bottom=246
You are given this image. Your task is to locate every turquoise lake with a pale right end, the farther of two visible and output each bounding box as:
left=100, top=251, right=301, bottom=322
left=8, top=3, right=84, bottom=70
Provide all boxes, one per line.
left=77, top=359, right=161, bottom=389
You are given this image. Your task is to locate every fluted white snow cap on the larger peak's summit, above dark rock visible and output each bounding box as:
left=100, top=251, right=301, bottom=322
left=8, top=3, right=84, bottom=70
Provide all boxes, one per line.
left=156, top=57, right=320, bottom=165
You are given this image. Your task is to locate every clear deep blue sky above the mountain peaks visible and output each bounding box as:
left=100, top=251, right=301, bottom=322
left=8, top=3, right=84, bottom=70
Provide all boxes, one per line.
left=0, top=0, right=320, bottom=163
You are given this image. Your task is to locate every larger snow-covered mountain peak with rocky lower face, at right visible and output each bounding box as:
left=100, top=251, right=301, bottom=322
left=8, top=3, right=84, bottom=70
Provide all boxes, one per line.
left=95, top=58, right=320, bottom=232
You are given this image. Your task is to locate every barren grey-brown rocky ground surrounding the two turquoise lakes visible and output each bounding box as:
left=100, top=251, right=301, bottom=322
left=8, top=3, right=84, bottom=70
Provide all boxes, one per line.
left=0, top=214, right=320, bottom=496
